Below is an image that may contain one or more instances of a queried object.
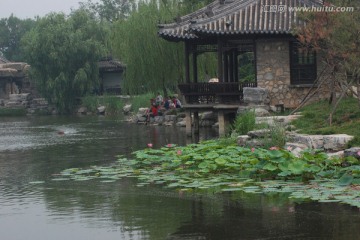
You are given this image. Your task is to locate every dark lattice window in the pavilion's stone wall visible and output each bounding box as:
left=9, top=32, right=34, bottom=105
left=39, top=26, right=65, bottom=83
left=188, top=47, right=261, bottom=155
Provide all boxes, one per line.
left=290, top=41, right=317, bottom=85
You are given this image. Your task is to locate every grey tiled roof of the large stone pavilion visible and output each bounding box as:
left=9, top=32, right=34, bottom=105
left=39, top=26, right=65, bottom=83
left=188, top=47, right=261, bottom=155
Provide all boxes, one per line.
left=158, top=0, right=322, bottom=41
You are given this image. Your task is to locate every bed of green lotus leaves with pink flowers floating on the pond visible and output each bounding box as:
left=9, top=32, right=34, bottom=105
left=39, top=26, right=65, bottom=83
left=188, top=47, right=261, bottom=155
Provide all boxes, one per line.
left=54, top=140, right=360, bottom=207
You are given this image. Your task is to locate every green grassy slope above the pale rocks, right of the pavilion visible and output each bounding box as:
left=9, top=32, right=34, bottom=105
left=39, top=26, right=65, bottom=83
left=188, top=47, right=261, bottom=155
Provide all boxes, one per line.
left=293, top=98, right=360, bottom=147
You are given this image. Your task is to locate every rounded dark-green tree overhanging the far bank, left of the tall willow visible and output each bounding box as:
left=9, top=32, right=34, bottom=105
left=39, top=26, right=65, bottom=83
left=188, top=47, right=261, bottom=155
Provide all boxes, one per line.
left=22, top=11, right=107, bottom=113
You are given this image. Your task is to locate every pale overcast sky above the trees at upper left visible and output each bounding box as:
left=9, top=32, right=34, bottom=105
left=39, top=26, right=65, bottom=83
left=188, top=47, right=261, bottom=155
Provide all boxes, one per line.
left=0, top=0, right=99, bottom=19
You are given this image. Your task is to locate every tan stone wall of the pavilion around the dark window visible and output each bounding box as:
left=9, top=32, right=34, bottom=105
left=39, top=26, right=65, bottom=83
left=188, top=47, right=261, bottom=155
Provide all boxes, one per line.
left=256, top=39, right=329, bottom=108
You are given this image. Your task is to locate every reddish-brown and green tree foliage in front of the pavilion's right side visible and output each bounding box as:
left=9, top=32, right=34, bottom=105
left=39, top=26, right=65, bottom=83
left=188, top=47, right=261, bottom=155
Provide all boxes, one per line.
left=298, top=0, right=360, bottom=120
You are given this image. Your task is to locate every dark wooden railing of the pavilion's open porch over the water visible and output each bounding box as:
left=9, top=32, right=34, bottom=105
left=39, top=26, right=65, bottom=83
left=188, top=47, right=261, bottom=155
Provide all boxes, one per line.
left=178, top=82, right=257, bottom=104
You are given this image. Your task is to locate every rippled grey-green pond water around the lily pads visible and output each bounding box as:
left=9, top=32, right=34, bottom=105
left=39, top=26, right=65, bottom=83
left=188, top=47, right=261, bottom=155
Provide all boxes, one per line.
left=0, top=117, right=360, bottom=240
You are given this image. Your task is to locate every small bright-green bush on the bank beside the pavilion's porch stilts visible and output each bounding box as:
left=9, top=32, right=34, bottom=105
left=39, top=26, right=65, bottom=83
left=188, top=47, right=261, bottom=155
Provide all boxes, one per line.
left=231, top=111, right=256, bottom=135
